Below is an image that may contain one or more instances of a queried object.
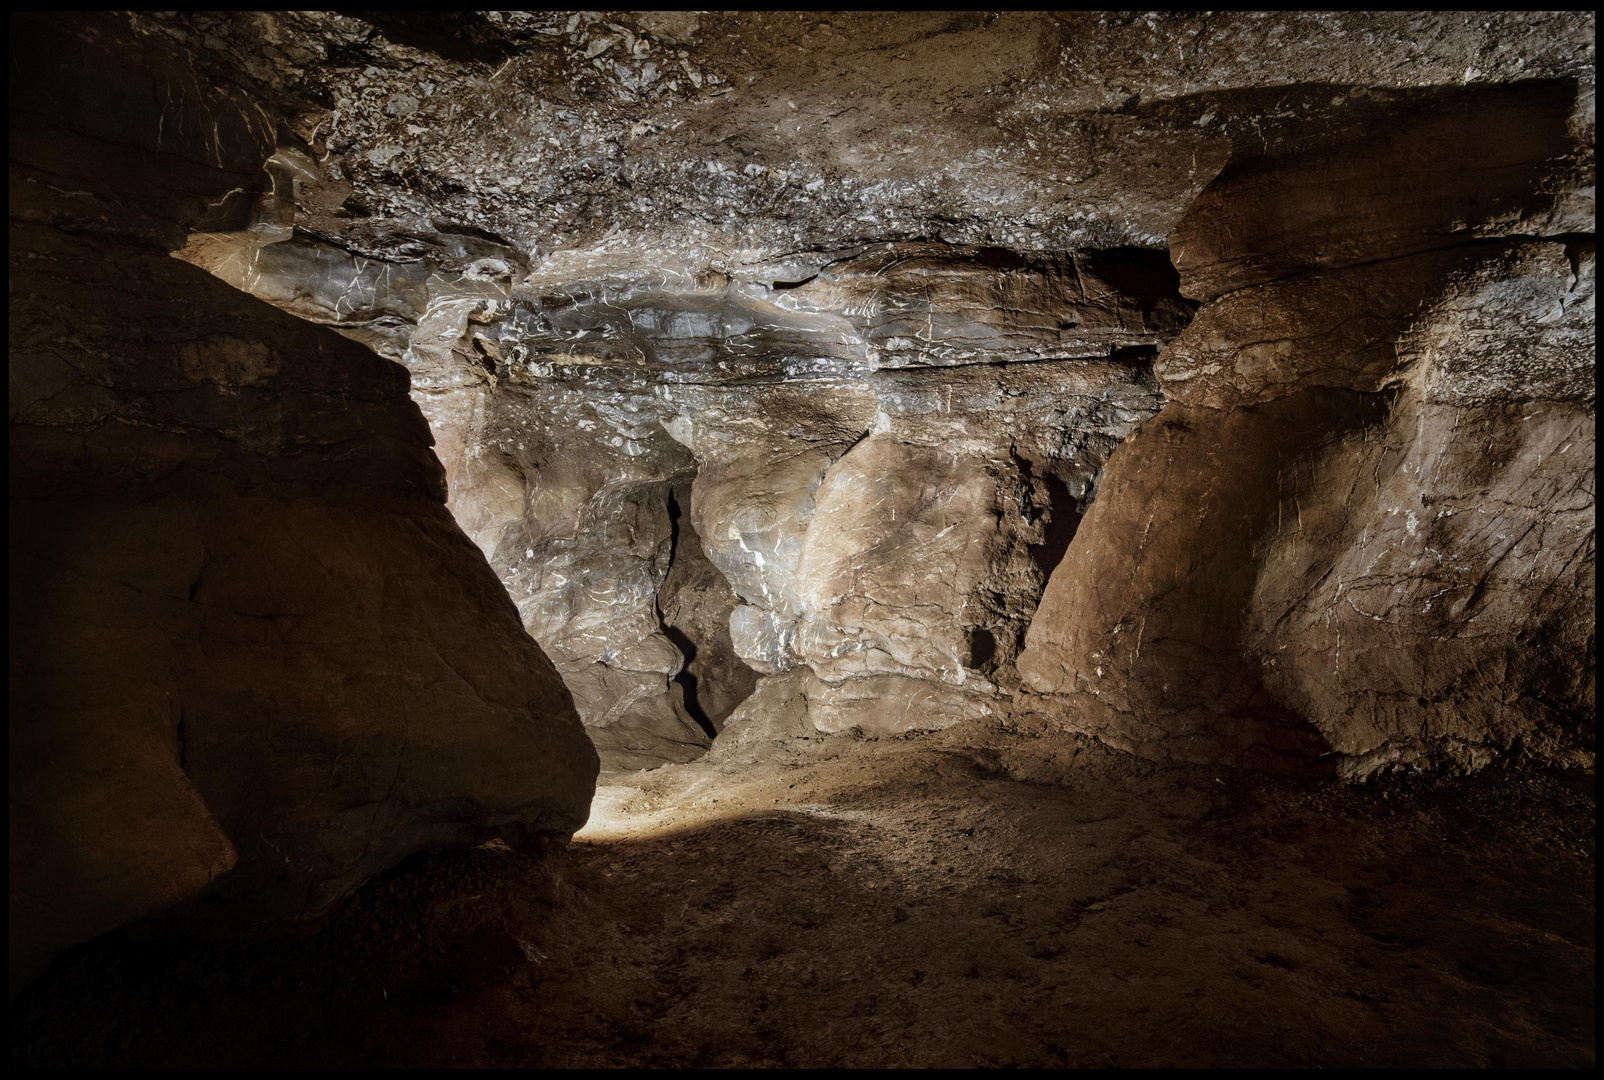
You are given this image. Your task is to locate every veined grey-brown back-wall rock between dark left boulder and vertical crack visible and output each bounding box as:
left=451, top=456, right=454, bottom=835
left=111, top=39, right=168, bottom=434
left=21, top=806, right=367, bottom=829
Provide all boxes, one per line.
left=436, top=380, right=707, bottom=767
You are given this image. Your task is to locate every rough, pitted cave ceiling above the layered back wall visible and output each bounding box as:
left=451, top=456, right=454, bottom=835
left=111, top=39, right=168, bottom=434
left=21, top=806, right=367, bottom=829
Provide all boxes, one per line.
left=136, top=11, right=1594, bottom=261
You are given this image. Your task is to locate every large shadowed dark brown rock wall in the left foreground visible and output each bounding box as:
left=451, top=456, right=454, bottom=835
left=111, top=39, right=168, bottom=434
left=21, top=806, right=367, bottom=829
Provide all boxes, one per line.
left=10, top=16, right=597, bottom=992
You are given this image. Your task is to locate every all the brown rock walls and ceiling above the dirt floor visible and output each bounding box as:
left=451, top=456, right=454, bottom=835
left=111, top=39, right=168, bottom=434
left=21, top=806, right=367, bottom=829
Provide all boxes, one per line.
left=11, top=11, right=1596, bottom=985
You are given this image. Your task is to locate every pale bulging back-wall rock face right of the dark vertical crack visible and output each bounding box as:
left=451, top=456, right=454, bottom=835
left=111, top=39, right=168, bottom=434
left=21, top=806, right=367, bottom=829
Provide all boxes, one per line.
left=670, top=361, right=1158, bottom=685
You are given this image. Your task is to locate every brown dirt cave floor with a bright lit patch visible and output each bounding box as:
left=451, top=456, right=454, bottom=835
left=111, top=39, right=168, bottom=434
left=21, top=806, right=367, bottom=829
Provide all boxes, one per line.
left=11, top=725, right=1594, bottom=1067
